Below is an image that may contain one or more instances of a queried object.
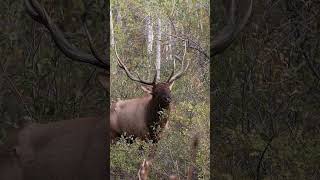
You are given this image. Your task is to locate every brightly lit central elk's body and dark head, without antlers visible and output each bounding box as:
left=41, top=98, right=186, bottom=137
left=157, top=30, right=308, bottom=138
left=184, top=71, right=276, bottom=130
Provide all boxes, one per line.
left=110, top=84, right=171, bottom=142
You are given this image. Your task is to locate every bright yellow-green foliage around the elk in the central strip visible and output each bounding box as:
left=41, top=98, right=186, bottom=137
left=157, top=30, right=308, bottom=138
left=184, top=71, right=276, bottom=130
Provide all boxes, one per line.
left=110, top=0, right=210, bottom=179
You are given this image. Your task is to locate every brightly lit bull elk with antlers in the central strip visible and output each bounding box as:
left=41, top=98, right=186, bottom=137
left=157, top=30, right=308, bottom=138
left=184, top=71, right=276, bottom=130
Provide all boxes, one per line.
left=110, top=42, right=190, bottom=143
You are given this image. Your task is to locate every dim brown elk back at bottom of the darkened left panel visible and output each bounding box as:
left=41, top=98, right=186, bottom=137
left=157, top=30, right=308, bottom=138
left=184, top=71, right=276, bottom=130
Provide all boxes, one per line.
left=16, top=118, right=107, bottom=180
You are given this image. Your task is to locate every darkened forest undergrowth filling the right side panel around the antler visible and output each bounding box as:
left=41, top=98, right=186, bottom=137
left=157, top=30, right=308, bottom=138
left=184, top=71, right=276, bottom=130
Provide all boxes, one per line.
left=211, top=0, right=320, bottom=179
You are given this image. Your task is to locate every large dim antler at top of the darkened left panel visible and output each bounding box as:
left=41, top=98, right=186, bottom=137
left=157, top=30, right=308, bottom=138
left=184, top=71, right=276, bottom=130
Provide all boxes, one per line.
left=24, top=0, right=110, bottom=71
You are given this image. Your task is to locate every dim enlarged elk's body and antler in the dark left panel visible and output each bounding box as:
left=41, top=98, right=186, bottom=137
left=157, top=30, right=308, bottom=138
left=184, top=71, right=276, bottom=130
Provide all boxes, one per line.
left=0, top=0, right=110, bottom=180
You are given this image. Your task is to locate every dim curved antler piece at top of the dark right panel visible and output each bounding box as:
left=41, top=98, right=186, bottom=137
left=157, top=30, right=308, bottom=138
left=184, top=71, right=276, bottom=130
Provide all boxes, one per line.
left=211, top=0, right=253, bottom=56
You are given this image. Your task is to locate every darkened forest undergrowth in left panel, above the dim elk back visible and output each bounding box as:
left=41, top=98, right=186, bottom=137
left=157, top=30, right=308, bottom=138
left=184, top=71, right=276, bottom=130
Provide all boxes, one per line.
left=0, top=0, right=108, bottom=143
